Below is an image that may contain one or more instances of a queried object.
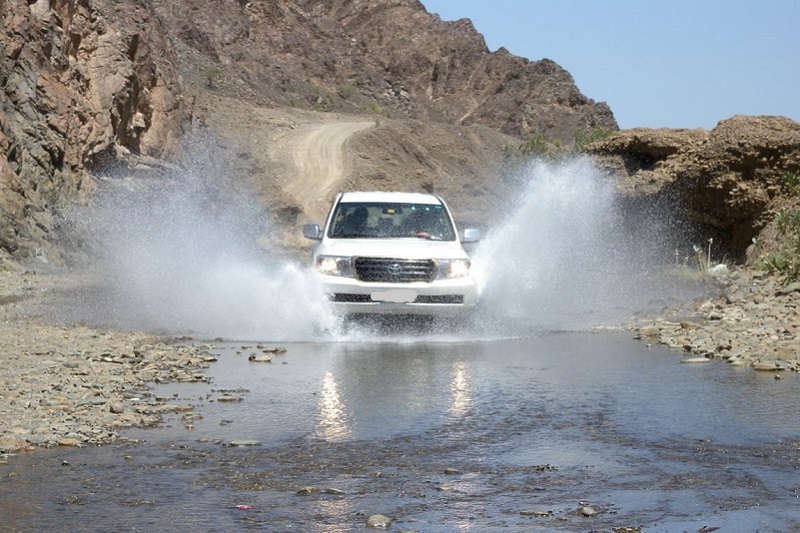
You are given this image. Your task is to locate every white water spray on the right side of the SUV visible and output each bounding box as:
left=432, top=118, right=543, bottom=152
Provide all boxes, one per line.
left=476, top=158, right=696, bottom=336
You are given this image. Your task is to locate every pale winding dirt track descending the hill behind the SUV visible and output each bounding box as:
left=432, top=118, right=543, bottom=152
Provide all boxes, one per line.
left=284, top=122, right=375, bottom=221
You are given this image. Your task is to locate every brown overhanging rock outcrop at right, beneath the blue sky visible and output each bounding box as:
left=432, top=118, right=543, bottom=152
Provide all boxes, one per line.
left=589, top=116, right=800, bottom=263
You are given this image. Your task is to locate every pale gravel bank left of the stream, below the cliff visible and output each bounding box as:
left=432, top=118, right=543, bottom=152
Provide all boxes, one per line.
left=0, top=272, right=214, bottom=453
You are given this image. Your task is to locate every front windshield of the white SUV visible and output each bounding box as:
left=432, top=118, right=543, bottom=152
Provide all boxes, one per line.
left=328, top=202, right=456, bottom=241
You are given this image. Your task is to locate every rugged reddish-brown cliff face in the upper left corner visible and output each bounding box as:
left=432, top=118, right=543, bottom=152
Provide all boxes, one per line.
left=0, top=0, right=186, bottom=261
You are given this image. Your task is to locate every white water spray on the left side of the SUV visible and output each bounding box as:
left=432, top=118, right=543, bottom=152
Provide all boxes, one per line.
left=66, top=135, right=328, bottom=341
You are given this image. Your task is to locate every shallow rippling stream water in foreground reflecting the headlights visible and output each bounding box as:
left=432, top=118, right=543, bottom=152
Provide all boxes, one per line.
left=0, top=333, right=800, bottom=532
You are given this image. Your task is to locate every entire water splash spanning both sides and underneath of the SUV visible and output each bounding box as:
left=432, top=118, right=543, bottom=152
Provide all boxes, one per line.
left=73, top=143, right=700, bottom=342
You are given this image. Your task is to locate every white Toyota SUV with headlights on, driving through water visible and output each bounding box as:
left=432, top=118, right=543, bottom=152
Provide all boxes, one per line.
left=303, top=192, right=480, bottom=315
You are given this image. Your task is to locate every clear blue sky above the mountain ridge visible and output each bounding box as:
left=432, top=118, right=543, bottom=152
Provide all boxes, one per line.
left=421, top=0, right=800, bottom=129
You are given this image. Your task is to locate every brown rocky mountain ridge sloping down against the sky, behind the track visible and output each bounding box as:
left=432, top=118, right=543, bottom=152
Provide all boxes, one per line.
left=155, top=0, right=616, bottom=142
